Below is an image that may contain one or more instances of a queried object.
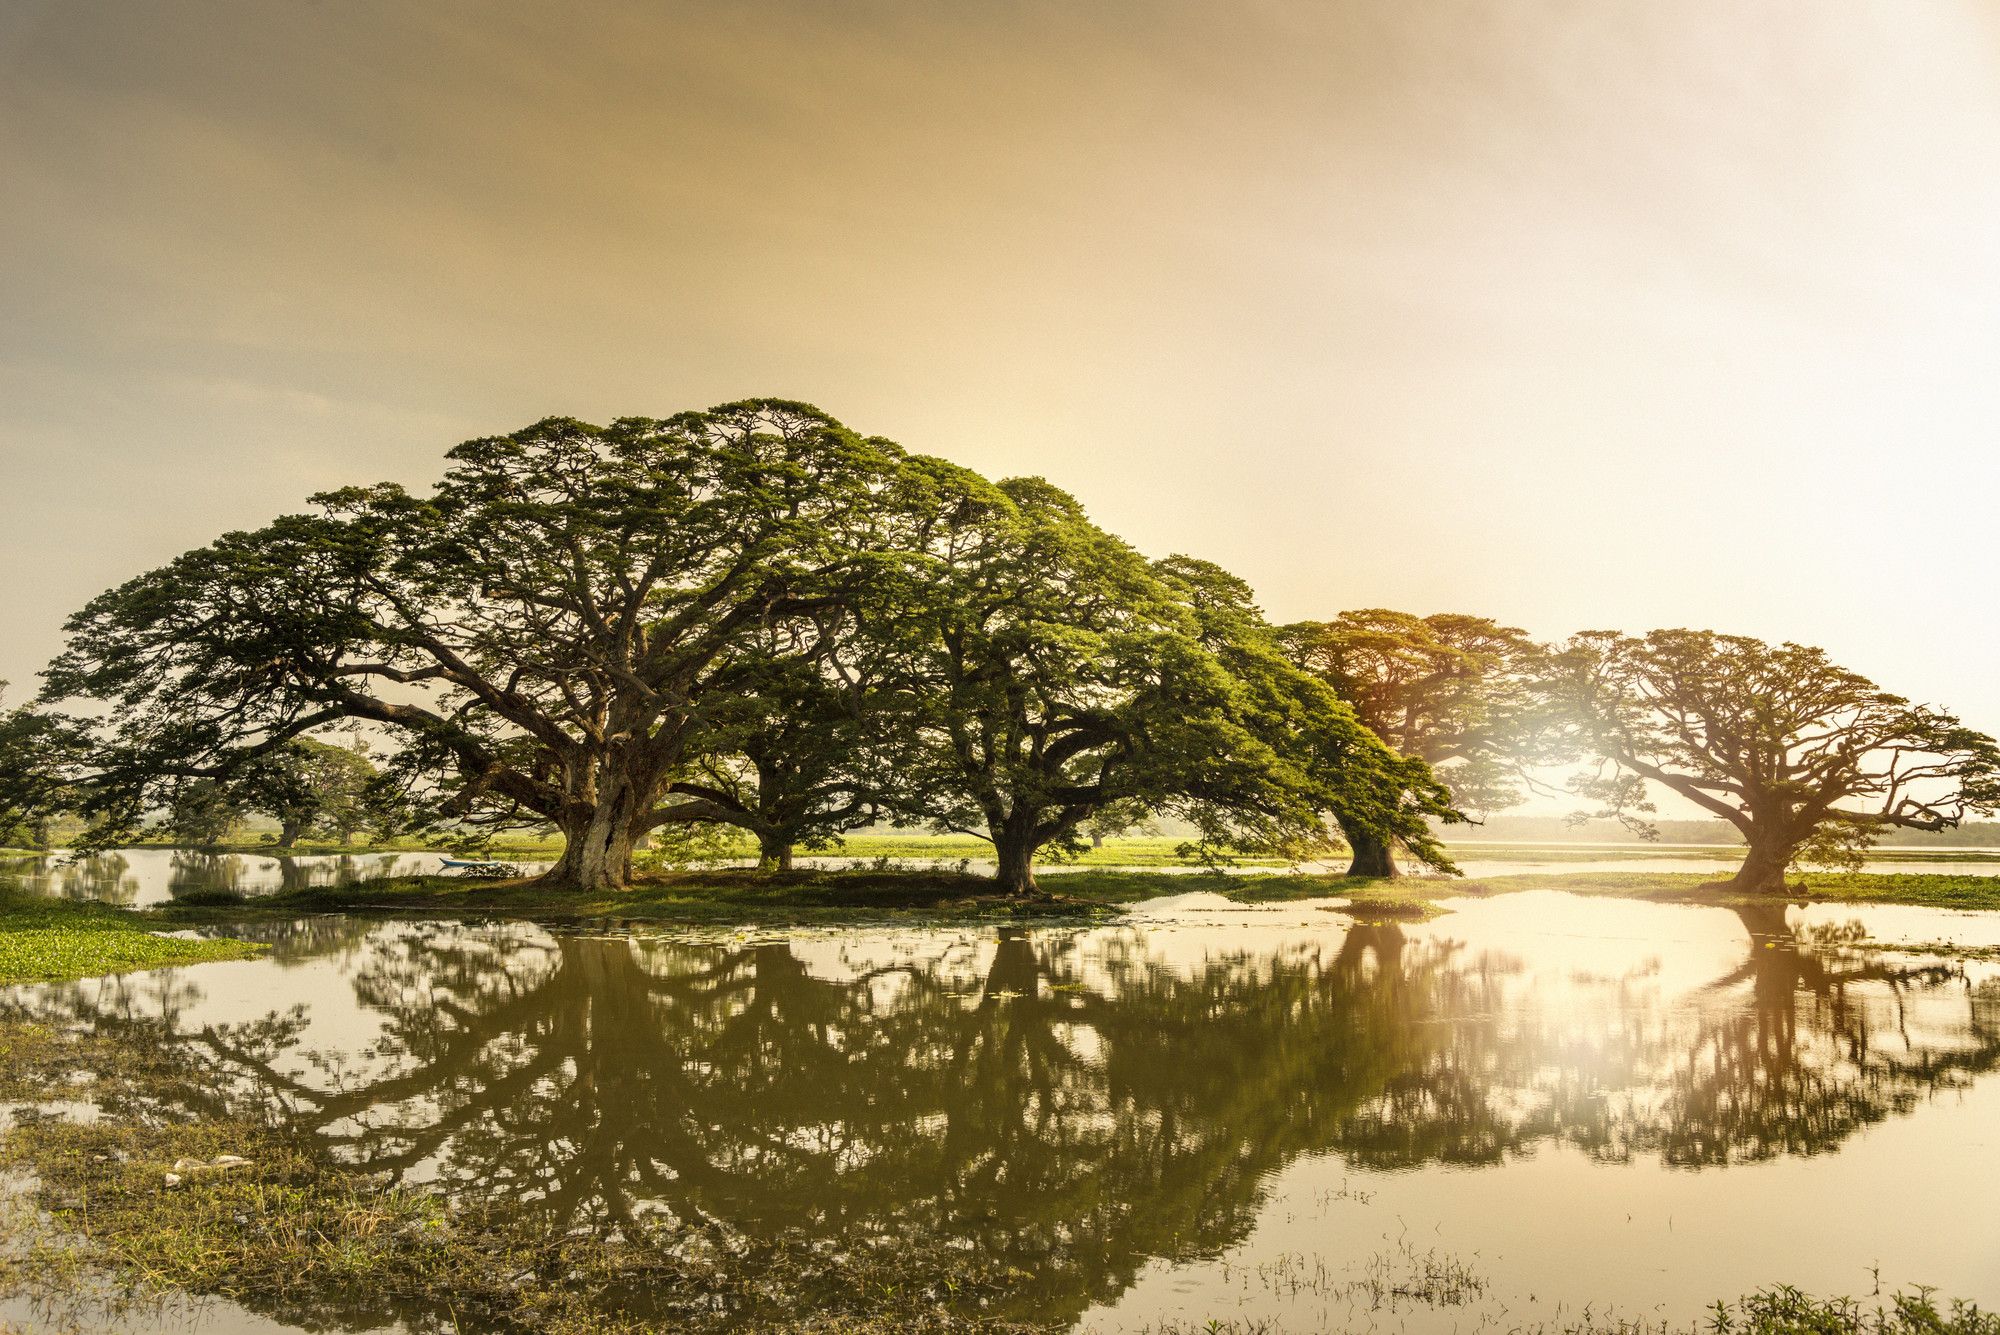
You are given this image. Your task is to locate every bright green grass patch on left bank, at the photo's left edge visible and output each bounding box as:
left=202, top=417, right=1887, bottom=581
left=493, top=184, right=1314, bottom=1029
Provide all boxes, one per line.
left=0, top=891, right=264, bottom=983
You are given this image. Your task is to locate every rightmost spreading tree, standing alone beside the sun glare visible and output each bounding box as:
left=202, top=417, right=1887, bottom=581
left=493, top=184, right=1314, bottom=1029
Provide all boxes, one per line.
left=1548, top=630, right=2000, bottom=893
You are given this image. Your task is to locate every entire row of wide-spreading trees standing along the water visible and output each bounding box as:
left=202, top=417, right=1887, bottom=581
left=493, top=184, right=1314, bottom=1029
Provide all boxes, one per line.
left=0, top=400, right=2000, bottom=893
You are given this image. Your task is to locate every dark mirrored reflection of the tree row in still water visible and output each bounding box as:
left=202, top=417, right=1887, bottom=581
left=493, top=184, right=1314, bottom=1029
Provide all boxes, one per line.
left=15, top=911, right=2000, bottom=1321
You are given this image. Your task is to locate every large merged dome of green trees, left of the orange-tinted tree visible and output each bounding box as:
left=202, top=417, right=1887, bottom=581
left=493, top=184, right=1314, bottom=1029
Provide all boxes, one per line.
left=31, top=400, right=1452, bottom=891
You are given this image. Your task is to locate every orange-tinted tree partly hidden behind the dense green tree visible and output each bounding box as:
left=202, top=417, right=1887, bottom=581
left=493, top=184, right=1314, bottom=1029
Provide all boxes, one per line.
left=1280, top=608, right=1540, bottom=875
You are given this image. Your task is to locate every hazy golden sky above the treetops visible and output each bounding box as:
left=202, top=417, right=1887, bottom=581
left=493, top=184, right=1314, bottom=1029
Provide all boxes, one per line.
left=0, top=0, right=2000, bottom=783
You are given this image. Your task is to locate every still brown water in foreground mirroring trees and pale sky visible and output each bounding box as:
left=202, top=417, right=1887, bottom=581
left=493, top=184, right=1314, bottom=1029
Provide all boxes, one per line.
left=0, top=891, right=2000, bottom=1335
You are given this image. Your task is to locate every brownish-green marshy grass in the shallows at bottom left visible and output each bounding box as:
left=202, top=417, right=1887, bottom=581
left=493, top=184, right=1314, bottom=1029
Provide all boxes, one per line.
left=0, top=1021, right=1042, bottom=1335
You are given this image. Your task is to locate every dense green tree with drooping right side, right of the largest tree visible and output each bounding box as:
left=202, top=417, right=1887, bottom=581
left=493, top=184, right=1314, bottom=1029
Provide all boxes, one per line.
left=858, top=460, right=1442, bottom=893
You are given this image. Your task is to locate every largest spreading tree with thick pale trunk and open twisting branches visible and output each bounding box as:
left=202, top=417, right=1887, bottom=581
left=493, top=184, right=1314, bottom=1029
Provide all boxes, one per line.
left=44, top=400, right=902, bottom=887
